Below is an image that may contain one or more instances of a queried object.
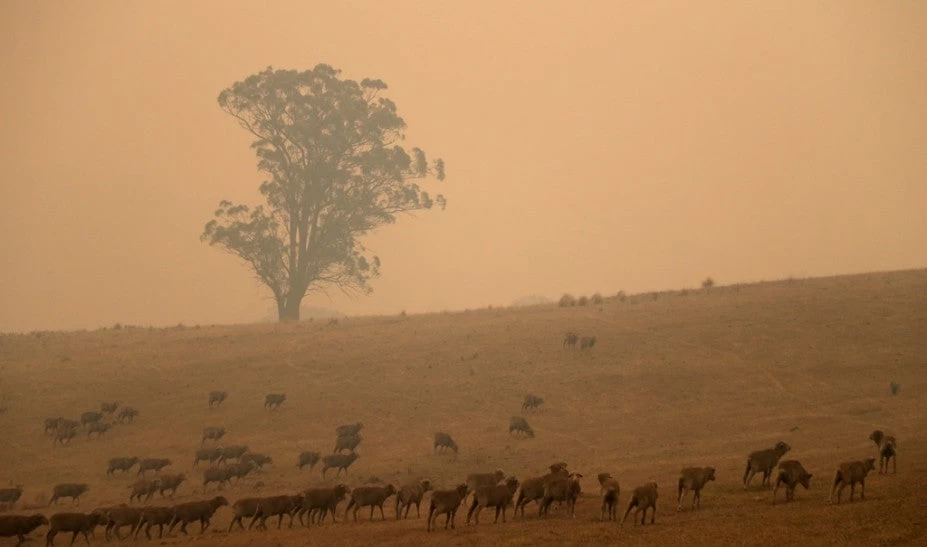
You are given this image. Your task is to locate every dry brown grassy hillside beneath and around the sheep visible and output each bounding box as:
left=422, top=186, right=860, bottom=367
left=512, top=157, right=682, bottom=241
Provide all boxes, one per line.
left=0, top=270, right=927, bottom=546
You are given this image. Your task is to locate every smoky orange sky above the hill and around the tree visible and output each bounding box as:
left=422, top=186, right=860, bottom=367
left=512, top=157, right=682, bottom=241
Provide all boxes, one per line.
left=0, top=0, right=927, bottom=331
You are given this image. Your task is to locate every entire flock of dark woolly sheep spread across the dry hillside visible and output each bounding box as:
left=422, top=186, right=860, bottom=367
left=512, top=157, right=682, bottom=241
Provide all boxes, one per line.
left=0, top=333, right=897, bottom=546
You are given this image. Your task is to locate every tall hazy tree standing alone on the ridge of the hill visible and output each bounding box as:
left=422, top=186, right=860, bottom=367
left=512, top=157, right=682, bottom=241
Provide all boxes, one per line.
left=201, top=64, right=446, bottom=321
